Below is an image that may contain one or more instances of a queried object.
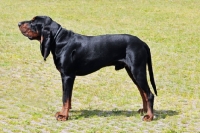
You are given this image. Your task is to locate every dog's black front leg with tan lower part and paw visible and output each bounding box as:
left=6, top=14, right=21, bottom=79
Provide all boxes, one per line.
left=56, top=73, right=75, bottom=121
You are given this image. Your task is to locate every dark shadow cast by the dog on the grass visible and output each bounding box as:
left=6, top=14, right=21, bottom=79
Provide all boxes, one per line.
left=70, top=109, right=179, bottom=120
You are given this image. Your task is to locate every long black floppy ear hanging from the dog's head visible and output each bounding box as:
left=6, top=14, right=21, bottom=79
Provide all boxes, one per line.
left=40, top=29, right=51, bottom=61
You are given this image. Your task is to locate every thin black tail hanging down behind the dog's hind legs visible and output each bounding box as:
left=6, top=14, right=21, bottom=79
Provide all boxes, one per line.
left=145, top=44, right=157, bottom=96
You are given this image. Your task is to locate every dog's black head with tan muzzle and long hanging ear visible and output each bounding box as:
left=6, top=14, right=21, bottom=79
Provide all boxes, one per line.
left=18, top=16, right=60, bottom=60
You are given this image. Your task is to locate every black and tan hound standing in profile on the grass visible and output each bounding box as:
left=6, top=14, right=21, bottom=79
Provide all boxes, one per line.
left=18, top=16, right=157, bottom=121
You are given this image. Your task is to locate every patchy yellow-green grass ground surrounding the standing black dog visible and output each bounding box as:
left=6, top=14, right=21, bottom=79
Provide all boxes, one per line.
left=0, top=0, right=200, bottom=133
